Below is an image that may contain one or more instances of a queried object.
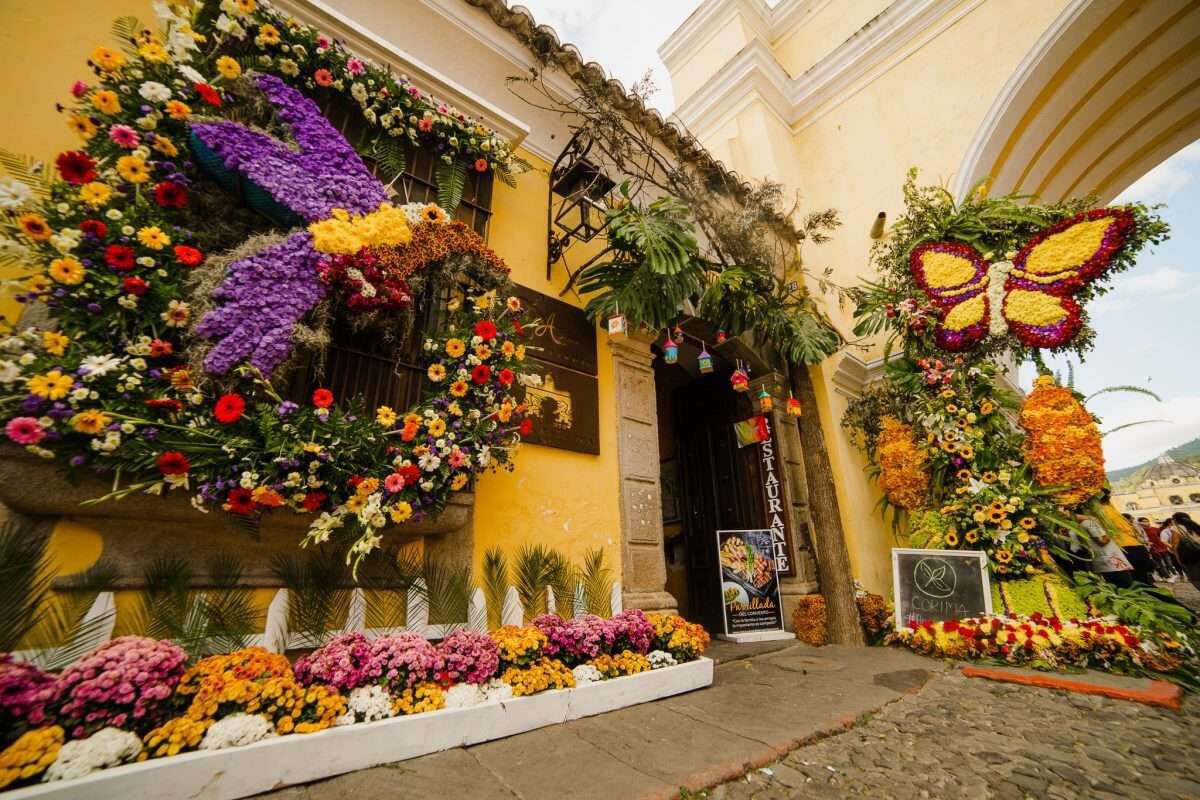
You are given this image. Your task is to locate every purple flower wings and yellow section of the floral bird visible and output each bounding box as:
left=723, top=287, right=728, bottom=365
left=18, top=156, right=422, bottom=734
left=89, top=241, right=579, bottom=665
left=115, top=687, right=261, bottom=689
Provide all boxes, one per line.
left=191, top=74, right=412, bottom=374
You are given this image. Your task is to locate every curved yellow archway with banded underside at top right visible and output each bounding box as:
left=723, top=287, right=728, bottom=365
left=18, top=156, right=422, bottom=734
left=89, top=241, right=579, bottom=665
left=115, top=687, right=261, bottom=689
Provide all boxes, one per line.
left=953, top=0, right=1200, bottom=203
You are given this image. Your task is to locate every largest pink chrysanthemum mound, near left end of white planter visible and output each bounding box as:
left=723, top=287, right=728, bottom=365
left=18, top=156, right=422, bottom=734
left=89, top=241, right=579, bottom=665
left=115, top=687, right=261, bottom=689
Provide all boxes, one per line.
left=56, top=636, right=187, bottom=739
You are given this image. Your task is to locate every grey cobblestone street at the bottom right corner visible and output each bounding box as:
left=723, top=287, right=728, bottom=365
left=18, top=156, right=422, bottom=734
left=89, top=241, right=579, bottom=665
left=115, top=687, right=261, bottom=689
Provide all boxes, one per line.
left=705, top=673, right=1200, bottom=800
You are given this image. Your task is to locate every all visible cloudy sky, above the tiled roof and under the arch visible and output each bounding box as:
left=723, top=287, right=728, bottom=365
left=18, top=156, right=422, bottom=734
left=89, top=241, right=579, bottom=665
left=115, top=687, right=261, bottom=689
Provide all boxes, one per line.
left=521, top=0, right=1200, bottom=469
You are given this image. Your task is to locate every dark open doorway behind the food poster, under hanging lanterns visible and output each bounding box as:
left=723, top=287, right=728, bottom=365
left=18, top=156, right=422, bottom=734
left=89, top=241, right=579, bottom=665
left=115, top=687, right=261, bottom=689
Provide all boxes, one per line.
left=673, top=373, right=766, bottom=632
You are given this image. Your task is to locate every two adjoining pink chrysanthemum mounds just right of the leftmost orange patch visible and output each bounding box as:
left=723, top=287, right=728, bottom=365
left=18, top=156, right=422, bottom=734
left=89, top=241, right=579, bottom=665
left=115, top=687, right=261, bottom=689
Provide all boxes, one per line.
left=294, top=632, right=442, bottom=692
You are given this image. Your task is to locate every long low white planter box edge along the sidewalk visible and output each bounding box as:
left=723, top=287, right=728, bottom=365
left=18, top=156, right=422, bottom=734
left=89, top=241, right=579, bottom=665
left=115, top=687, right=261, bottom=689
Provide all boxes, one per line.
left=2, top=658, right=713, bottom=800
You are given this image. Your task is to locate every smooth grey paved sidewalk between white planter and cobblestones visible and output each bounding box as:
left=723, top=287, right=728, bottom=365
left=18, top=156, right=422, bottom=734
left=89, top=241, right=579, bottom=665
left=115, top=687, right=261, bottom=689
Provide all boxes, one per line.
left=259, top=643, right=948, bottom=800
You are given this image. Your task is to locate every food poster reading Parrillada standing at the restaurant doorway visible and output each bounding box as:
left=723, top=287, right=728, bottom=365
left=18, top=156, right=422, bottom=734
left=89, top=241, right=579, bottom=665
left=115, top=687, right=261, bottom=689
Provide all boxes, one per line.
left=716, top=529, right=784, bottom=633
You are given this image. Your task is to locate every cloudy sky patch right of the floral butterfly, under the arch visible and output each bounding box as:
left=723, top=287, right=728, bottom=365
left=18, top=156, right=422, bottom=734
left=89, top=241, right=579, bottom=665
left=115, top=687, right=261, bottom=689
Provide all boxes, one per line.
left=1021, top=142, right=1200, bottom=469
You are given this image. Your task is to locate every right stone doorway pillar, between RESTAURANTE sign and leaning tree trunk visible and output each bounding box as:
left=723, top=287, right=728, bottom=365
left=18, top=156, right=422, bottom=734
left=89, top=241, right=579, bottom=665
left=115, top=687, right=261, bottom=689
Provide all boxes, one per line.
left=750, top=372, right=818, bottom=631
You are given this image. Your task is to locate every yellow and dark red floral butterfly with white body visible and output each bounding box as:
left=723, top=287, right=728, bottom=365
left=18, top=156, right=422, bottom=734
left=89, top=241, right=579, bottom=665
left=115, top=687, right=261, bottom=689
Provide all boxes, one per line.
left=908, top=209, right=1135, bottom=350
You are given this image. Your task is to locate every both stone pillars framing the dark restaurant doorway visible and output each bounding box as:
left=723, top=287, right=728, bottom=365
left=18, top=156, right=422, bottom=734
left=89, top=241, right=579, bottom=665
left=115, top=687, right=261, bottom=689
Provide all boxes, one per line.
left=608, top=335, right=817, bottom=628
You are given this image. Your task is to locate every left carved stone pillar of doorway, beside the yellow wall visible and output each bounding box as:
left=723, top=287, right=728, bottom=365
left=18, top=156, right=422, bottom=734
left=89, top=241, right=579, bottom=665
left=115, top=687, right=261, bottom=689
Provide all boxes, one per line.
left=608, top=335, right=677, bottom=610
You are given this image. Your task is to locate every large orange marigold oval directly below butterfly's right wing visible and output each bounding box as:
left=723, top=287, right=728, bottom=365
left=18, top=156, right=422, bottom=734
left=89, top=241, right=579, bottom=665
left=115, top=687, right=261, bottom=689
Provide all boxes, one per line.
left=1021, top=375, right=1104, bottom=506
